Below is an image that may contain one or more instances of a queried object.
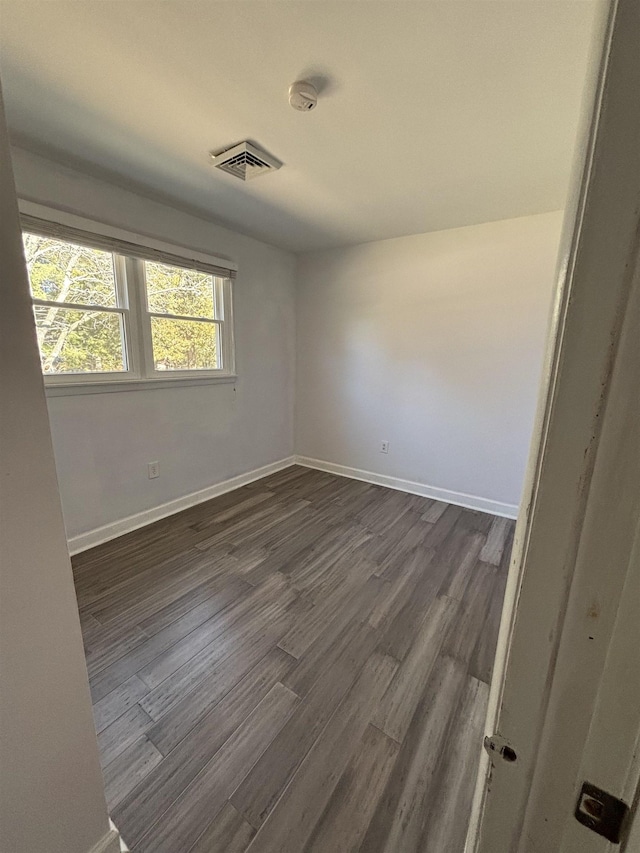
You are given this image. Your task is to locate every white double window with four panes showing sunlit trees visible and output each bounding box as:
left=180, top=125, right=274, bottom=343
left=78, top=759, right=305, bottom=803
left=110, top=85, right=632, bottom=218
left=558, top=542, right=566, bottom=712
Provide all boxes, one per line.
left=23, top=221, right=234, bottom=392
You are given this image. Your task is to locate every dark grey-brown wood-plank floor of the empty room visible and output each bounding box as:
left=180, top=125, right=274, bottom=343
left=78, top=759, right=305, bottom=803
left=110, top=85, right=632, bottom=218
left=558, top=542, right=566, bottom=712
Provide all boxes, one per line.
left=73, top=467, right=513, bottom=853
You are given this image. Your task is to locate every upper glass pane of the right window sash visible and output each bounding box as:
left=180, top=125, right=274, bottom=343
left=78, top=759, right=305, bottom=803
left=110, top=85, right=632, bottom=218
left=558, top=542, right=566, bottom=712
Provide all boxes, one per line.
left=144, top=261, right=215, bottom=319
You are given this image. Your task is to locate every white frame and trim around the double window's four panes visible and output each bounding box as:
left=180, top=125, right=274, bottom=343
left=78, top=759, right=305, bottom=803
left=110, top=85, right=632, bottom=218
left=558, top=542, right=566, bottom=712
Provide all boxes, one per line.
left=19, top=200, right=237, bottom=396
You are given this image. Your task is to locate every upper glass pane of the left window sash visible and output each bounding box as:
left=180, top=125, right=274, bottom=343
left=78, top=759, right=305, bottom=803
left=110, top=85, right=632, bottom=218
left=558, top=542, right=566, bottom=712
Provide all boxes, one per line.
left=23, top=234, right=117, bottom=308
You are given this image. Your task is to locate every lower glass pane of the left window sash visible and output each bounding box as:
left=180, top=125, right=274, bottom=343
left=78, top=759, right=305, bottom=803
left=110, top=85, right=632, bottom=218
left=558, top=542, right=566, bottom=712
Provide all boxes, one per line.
left=34, top=305, right=127, bottom=375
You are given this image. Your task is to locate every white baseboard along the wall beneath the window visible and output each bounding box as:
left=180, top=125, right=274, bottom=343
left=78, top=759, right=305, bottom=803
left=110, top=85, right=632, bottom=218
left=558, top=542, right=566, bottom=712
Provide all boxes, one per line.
left=68, top=456, right=295, bottom=554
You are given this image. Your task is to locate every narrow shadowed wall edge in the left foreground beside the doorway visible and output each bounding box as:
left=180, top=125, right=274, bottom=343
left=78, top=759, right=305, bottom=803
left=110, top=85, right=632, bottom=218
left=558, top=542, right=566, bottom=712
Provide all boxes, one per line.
left=0, top=91, right=112, bottom=853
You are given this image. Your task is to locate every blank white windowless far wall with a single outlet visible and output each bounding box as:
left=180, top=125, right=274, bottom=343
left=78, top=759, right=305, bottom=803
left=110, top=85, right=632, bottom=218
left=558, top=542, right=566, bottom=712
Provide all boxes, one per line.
left=296, top=212, right=562, bottom=513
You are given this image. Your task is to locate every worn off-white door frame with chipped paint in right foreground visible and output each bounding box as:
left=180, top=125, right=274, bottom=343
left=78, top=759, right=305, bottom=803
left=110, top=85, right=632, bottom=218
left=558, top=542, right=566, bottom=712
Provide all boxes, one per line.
left=466, top=0, right=640, bottom=853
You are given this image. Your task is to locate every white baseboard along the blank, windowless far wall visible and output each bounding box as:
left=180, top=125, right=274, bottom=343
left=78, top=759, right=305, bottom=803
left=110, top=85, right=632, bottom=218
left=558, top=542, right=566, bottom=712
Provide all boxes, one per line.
left=295, top=456, right=518, bottom=518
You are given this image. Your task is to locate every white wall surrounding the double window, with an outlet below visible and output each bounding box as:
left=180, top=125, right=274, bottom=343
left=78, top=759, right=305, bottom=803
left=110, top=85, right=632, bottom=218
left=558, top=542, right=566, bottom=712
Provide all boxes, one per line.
left=14, top=149, right=295, bottom=538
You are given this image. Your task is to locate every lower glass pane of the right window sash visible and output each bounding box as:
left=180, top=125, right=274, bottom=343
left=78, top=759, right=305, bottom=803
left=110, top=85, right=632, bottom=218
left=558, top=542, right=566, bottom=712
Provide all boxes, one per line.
left=151, top=317, right=218, bottom=370
